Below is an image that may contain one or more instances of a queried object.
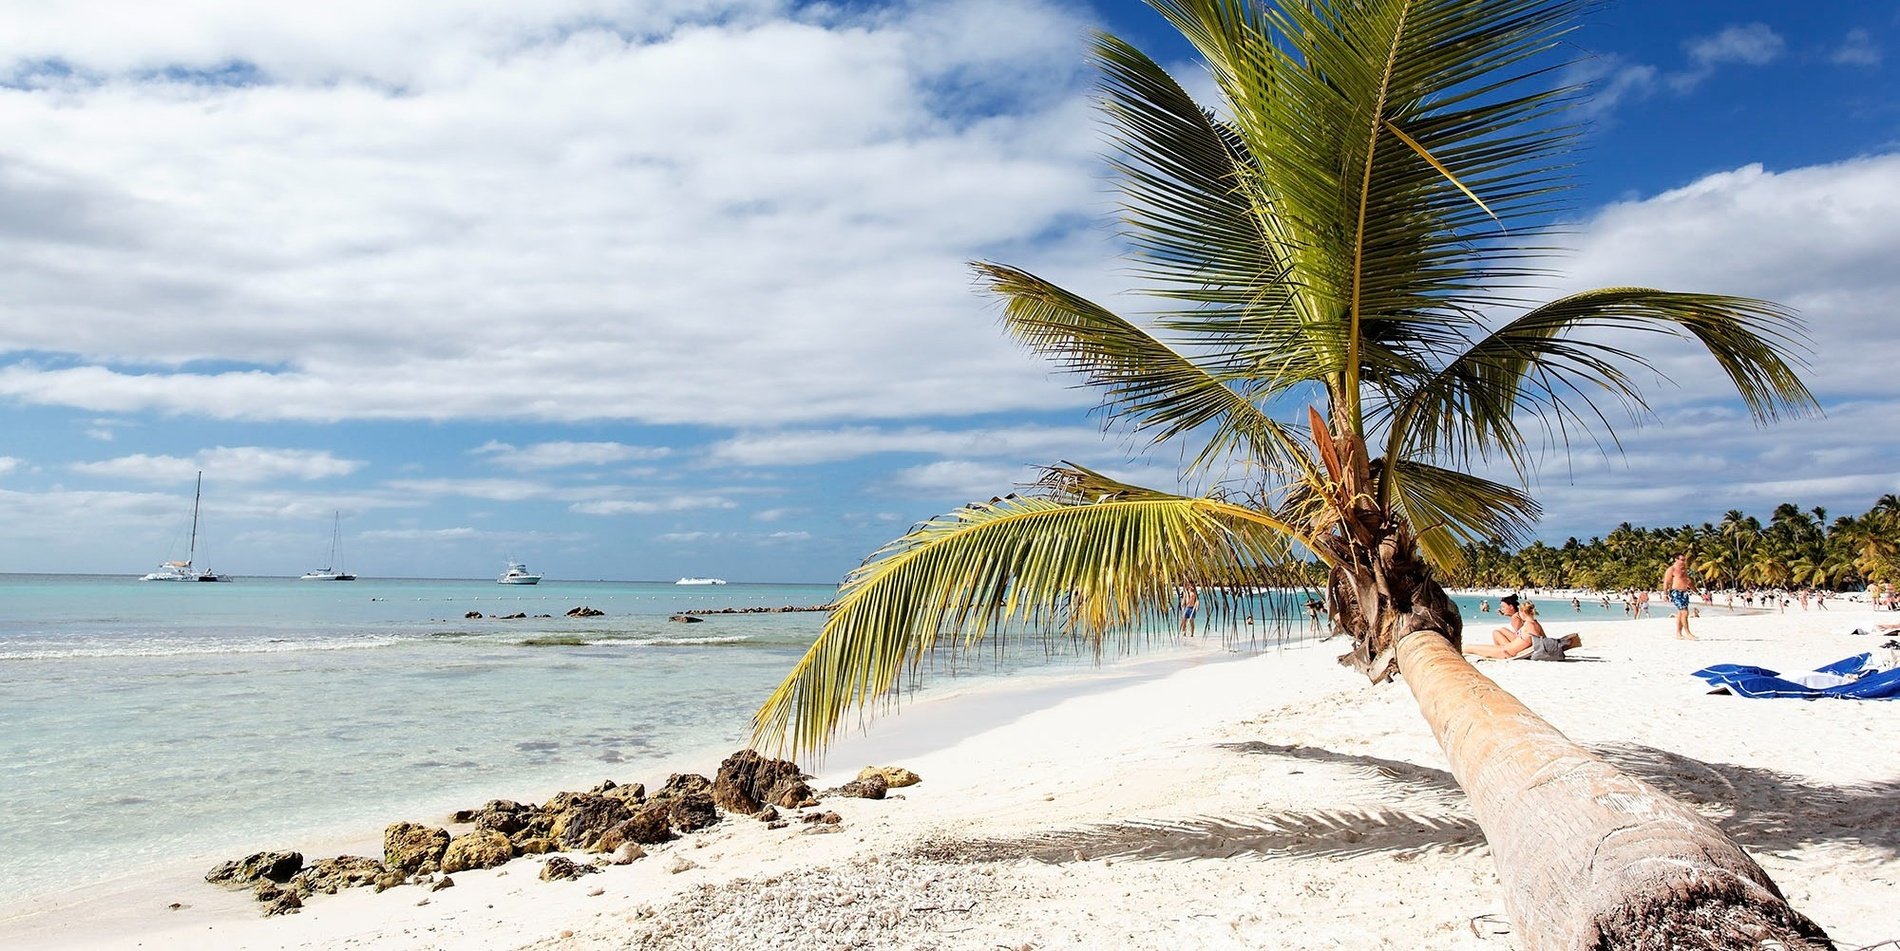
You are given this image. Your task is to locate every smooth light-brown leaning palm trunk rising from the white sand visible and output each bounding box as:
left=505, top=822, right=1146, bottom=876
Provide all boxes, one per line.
left=1395, top=630, right=1834, bottom=951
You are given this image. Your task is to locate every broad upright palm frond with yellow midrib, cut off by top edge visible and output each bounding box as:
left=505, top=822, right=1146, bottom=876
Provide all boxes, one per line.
left=1151, top=0, right=1587, bottom=420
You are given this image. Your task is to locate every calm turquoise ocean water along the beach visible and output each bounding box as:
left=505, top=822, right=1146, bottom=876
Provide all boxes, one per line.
left=0, top=575, right=1623, bottom=917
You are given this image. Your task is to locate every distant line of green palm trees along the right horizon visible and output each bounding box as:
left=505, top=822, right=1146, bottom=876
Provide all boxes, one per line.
left=1448, top=494, right=1900, bottom=590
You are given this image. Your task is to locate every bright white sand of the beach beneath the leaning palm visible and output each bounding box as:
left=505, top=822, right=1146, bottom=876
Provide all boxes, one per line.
left=14, top=602, right=1900, bottom=949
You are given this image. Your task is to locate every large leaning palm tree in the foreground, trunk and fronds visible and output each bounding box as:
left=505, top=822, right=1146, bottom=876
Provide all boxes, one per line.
left=756, top=0, right=1826, bottom=947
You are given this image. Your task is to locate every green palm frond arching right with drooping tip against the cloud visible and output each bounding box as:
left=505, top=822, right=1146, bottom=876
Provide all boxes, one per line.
left=1387, top=287, right=1816, bottom=482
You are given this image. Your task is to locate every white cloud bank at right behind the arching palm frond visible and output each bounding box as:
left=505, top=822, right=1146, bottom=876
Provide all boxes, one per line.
left=1512, top=154, right=1900, bottom=533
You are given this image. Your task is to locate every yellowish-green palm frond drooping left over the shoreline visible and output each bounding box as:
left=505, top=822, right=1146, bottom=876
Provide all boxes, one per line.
left=754, top=494, right=1300, bottom=752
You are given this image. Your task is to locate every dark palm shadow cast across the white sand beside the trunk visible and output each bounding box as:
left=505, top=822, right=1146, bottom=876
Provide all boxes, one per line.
left=914, top=742, right=1900, bottom=864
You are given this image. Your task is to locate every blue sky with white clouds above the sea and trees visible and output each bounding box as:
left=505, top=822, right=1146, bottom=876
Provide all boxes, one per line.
left=0, top=0, right=1900, bottom=583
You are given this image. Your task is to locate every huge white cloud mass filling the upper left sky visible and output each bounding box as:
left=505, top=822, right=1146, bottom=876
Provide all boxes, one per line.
left=0, top=0, right=1106, bottom=425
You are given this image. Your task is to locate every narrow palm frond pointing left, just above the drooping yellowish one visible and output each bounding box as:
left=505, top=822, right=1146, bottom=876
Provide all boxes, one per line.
left=975, top=264, right=1311, bottom=473
